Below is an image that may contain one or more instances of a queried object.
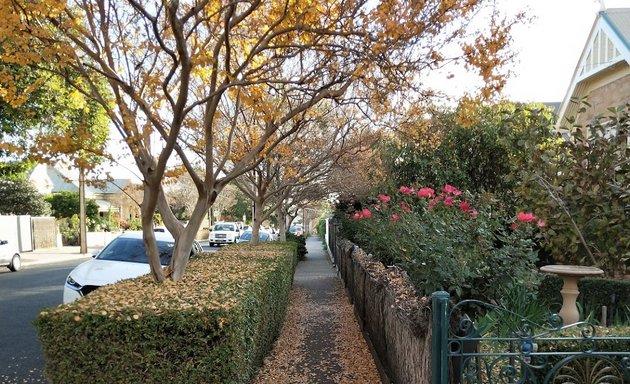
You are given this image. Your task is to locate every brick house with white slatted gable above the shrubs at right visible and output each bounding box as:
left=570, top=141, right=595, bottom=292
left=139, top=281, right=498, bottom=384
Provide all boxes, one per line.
left=557, top=2, right=630, bottom=132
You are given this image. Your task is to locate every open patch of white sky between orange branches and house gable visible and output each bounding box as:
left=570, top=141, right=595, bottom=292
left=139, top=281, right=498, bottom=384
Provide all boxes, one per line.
left=500, top=0, right=630, bottom=102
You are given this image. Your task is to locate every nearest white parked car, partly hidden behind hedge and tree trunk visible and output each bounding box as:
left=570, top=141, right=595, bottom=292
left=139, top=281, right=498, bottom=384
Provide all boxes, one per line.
left=63, top=232, right=203, bottom=304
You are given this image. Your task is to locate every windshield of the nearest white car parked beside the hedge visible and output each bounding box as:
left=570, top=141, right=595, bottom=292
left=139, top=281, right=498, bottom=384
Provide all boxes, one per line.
left=96, top=238, right=175, bottom=265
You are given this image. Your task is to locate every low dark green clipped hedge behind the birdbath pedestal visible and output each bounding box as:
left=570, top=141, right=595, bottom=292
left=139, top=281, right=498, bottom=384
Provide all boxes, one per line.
left=538, top=275, right=630, bottom=325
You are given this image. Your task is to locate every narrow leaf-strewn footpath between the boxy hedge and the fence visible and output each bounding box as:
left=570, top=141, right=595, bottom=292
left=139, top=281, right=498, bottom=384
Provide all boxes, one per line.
left=253, top=237, right=388, bottom=384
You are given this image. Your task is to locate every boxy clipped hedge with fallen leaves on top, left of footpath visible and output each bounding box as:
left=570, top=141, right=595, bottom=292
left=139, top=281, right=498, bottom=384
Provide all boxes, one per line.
left=34, top=242, right=297, bottom=383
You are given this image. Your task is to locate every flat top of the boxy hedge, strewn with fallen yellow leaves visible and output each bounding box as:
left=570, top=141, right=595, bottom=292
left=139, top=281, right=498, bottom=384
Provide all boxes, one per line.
left=41, top=243, right=295, bottom=321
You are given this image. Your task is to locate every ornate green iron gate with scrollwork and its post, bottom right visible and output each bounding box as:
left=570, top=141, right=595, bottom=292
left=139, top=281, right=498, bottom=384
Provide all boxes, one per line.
left=432, top=291, right=630, bottom=384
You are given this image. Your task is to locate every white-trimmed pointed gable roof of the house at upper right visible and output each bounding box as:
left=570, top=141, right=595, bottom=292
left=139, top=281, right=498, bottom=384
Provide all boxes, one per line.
left=558, top=8, right=630, bottom=125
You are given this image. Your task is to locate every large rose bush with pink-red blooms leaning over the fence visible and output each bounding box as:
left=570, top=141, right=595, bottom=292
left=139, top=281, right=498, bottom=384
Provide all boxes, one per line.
left=338, top=184, right=545, bottom=300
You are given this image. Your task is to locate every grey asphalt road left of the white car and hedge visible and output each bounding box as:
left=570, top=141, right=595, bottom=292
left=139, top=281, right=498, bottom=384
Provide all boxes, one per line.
left=0, top=261, right=80, bottom=384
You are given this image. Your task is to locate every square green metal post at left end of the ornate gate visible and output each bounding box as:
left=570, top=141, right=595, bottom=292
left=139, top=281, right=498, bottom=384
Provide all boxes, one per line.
left=431, top=291, right=449, bottom=384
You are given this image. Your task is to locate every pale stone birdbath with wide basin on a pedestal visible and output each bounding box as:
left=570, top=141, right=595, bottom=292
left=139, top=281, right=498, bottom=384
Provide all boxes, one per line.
left=540, top=265, right=604, bottom=325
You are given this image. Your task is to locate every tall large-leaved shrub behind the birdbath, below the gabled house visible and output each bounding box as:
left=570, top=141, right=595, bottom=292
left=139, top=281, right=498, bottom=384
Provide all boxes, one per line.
left=515, top=106, right=630, bottom=276
